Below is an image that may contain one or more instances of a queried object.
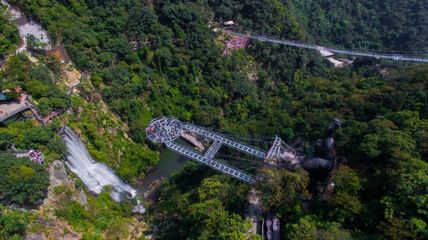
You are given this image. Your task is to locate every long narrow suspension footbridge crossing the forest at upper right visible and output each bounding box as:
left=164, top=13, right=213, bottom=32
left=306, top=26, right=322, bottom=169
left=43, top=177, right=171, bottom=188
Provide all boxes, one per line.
left=226, top=30, right=428, bottom=63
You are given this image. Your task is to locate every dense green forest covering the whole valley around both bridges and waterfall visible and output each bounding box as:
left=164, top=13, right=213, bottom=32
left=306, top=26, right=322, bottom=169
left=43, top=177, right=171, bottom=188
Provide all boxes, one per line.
left=0, top=0, right=428, bottom=240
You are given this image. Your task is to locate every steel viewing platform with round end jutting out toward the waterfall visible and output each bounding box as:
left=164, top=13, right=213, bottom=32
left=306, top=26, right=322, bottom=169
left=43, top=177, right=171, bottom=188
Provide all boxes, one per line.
left=146, top=117, right=300, bottom=184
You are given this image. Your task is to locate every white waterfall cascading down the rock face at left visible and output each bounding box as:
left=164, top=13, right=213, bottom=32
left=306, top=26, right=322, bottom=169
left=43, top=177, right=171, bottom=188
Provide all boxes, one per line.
left=62, top=127, right=137, bottom=202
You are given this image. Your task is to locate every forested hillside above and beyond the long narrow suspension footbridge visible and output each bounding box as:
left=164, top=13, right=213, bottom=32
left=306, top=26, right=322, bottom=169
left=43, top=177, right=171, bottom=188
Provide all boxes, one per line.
left=208, top=0, right=428, bottom=53
